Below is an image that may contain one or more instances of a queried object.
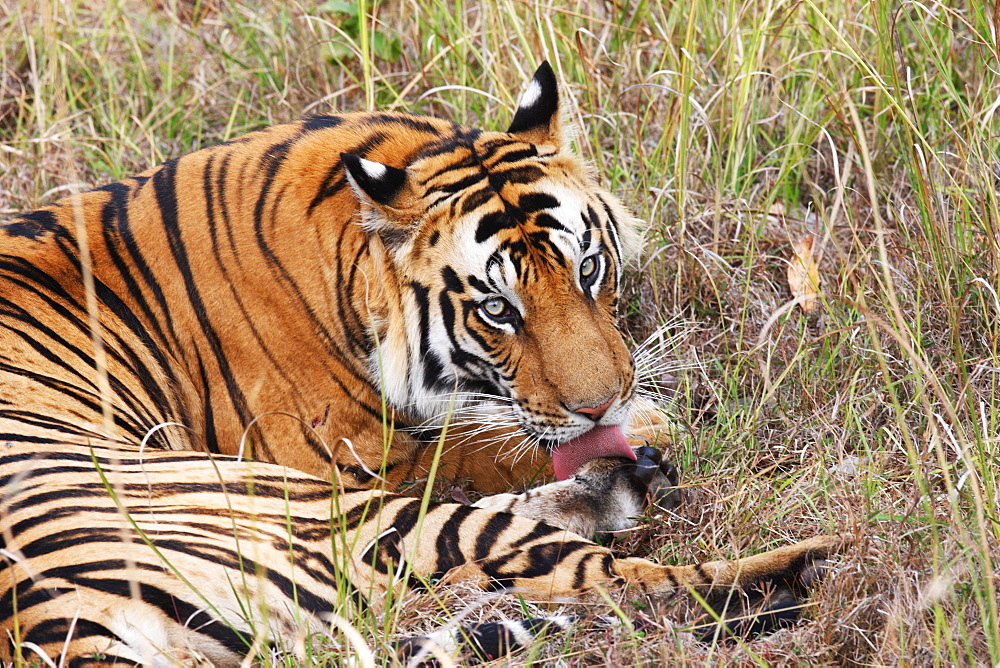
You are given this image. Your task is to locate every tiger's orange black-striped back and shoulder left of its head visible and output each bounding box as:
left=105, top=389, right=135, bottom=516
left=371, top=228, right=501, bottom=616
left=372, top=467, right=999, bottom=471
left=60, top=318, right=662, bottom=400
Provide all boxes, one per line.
left=0, top=114, right=455, bottom=473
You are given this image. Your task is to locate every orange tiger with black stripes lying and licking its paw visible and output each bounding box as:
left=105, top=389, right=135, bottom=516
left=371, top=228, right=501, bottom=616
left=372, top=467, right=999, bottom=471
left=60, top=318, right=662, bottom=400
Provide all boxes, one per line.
left=0, top=62, right=852, bottom=665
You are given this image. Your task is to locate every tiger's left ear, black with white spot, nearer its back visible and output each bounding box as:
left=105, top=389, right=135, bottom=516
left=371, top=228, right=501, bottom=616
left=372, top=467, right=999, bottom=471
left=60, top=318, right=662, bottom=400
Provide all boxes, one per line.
left=340, top=153, right=415, bottom=246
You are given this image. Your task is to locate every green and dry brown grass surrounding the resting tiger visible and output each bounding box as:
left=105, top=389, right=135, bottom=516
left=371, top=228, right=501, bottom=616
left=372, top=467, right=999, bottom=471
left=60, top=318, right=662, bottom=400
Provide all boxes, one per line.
left=0, top=0, right=1000, bottom=665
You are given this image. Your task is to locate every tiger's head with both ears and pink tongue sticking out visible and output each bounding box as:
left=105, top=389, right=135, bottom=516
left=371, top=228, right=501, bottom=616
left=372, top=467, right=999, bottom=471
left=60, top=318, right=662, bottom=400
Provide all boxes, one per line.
left=341, top=63, right=637, bottom=479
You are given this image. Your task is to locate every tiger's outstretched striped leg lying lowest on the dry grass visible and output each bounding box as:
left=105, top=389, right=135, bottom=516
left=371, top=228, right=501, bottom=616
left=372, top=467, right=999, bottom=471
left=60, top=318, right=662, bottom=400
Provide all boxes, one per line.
left=376, top=501, right=854, bottom=632
